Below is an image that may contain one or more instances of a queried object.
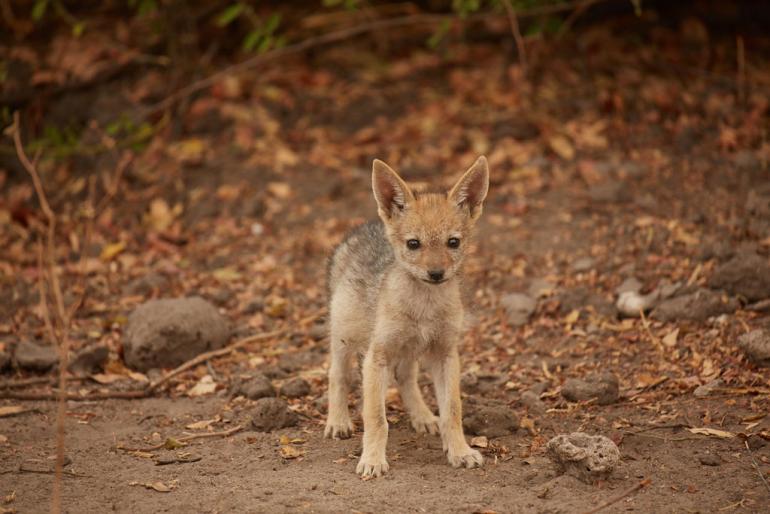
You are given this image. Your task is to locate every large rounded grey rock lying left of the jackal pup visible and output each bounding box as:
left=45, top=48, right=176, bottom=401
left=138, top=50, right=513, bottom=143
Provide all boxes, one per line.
left=123, top=297, right=230, bottom=371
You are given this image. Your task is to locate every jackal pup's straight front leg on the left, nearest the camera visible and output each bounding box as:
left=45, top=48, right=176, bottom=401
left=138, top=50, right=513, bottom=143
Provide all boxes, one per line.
left=356, top=345, right=389, bottom=477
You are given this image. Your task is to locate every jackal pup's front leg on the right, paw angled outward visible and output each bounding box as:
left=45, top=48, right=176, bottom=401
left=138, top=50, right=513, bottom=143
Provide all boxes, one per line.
left=432, top=346, right=484, bottom=468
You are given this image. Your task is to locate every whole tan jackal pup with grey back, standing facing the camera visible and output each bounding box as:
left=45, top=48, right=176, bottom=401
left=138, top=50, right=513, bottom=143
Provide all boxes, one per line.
left=324, top=157, right=489, bottom=476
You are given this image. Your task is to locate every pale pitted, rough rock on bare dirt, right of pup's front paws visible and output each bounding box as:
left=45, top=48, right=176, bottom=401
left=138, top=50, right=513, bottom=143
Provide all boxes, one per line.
left=546, top=432, right=620, bottom=484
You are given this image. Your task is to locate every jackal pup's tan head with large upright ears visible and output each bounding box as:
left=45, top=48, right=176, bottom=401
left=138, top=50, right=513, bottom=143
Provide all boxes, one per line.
left=372, top=156, right=489, bottom=284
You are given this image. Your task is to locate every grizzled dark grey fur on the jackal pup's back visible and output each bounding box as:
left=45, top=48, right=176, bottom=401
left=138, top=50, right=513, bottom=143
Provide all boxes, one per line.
left=328, top=216, right=394, bottom=305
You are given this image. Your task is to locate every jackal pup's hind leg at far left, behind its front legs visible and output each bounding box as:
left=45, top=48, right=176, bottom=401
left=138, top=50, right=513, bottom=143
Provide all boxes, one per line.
left=324, top=327, right=355, bottom=439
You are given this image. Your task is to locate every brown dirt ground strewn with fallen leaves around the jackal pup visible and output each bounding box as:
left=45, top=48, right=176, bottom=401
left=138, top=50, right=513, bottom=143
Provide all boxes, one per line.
left=0, top=5, right=770, bottom=514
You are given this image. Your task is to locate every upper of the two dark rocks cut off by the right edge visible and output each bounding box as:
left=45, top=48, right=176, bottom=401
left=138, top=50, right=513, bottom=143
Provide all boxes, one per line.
left=709, top=253, right=770, bottom=302
